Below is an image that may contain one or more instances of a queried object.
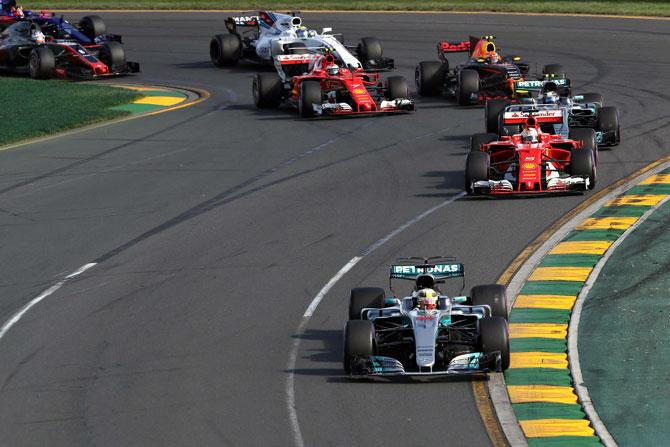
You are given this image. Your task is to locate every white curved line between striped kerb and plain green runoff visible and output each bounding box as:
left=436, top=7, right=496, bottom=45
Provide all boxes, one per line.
left=568, top=195, right=670, bottom=447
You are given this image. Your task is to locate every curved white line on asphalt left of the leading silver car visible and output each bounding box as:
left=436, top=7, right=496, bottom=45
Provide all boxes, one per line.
left=286, top=192, right=465, bottom=447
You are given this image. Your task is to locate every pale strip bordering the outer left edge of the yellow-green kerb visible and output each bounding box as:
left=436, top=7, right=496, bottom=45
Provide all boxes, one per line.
left=487, top=162, right=670, bottom=447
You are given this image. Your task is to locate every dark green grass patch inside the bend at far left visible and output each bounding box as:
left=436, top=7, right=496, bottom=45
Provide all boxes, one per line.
left=0, top=77, right=139, bottom=146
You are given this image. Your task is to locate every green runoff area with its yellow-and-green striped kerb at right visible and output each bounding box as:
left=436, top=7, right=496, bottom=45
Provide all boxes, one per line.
left=505, top=163, right=670, bottom=447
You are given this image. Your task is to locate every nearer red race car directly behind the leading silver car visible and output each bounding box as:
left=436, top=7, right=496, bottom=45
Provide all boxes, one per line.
left=465, top=117, right=596, bottom=195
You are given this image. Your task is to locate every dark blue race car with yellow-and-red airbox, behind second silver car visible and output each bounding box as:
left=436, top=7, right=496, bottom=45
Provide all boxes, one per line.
left=415, top=36, right=563, bottom=105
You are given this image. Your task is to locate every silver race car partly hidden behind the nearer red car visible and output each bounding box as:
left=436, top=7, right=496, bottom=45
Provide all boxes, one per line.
left=485, top=79, right=621, bottom=146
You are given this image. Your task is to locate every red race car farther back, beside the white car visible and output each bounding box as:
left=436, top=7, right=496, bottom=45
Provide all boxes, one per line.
left=252, top=54, right=414, bottom=118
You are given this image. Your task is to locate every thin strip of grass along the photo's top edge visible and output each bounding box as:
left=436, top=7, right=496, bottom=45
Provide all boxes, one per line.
left=24, top=0, right=670, bottom=17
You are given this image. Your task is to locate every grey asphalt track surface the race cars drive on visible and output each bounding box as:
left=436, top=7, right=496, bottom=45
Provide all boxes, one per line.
left=0, top=13, right=670, bottom=446
